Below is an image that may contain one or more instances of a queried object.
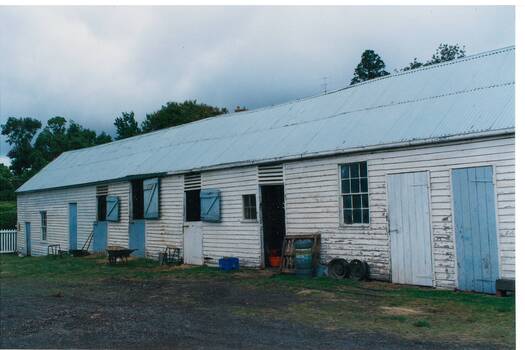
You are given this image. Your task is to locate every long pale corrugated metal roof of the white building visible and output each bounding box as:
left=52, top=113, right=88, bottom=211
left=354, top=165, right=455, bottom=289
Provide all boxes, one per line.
left=18, top=47, right=515, bottom=192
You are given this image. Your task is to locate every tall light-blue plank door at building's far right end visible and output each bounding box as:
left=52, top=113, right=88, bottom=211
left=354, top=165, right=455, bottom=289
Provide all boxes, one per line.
left=452, top=166, right=499, bottom=293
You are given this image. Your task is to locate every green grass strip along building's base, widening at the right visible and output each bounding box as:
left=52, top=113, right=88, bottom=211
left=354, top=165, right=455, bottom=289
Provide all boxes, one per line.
left=0, top=256, right=515, bottom=347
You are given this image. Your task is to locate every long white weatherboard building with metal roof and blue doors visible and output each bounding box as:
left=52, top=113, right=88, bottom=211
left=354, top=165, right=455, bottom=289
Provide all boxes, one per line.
left=18, top=47, right=515, bottom=292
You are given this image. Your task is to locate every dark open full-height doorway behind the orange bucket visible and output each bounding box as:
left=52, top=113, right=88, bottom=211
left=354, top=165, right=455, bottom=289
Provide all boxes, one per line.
left=261, top=185, right=286, bottom=266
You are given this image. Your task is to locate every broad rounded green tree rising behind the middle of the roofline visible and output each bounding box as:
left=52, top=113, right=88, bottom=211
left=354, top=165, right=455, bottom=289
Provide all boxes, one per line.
left=142, top=100, right=228, bottom=133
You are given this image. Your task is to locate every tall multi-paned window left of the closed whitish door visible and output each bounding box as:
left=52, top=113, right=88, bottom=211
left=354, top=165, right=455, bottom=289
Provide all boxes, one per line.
left=341, top=162, right=370, bottom=224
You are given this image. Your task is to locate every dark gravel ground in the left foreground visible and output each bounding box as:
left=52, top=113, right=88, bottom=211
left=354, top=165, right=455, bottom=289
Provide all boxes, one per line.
left=0, top=279, right=500, bottom=349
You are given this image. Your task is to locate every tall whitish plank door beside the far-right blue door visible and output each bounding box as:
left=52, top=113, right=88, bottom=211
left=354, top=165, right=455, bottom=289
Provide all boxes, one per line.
left=387, top=171, right=432, bottom=286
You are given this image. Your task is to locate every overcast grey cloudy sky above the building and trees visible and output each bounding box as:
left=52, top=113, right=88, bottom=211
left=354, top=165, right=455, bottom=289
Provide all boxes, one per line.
left=0, top=6, right=515, bottom=163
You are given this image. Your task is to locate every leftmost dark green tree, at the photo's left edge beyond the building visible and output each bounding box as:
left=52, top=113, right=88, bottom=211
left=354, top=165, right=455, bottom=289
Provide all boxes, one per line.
left=2, top=117, right=42, bottom=175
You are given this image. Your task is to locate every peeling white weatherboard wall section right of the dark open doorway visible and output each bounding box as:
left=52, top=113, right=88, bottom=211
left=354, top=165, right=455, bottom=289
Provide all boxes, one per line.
left=285, top=138, right=515, bottom=288
